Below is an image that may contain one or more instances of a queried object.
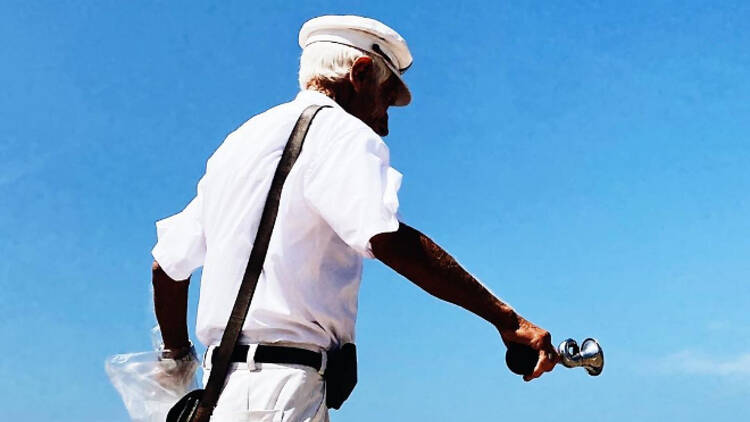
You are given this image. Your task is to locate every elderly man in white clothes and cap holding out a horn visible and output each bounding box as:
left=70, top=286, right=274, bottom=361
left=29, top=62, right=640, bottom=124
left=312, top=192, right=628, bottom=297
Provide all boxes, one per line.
left=153, top=16, right=557, bottom=421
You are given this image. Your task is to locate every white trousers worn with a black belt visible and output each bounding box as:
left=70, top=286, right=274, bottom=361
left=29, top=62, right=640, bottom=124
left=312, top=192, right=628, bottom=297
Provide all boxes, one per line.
left=203, top=351, right=328, bottom=422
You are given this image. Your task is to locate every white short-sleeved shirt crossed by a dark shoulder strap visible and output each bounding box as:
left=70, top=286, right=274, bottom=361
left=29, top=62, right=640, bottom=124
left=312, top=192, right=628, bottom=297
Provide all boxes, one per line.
left=152, top=91, right=401, bottom=349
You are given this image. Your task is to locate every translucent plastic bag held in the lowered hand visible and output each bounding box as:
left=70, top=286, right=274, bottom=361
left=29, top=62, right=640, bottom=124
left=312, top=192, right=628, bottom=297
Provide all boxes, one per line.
left=105, top=326, right=199, bottom=422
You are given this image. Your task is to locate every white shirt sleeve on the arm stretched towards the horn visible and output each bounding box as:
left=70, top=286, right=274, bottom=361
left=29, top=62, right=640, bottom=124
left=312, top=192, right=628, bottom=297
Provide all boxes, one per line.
left=304, top=131, right=402, bottom=258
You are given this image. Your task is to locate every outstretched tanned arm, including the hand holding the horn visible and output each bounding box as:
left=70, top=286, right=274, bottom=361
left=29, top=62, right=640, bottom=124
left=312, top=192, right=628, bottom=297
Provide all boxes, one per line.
left=370, top=223, right=558, bottom=381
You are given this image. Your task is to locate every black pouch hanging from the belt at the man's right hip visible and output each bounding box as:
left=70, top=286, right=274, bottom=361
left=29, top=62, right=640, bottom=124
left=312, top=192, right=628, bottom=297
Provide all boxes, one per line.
left=323, top=343, right=357, bottom=409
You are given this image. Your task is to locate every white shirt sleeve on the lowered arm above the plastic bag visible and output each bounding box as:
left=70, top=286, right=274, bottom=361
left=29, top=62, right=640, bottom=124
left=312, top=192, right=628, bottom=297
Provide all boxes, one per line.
left=151, top=188, right=206, bottom=280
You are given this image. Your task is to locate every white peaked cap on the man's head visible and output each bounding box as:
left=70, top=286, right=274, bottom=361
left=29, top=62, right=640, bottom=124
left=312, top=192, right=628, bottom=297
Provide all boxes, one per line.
left=299, top=15, right=412, bottom=106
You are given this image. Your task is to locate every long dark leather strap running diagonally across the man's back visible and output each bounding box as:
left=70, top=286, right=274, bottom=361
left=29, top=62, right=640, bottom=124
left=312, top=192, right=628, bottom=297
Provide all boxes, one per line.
left=200, top=105, right=330, bottom=414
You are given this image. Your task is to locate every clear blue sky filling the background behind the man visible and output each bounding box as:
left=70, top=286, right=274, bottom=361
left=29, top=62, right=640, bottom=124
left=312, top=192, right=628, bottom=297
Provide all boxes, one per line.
left=0, top=1, right=750, bottom=421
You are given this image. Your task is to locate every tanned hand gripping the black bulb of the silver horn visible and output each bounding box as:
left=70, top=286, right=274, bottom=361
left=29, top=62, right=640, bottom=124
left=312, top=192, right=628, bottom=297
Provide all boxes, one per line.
left=498, top=316, right=560, bottom=381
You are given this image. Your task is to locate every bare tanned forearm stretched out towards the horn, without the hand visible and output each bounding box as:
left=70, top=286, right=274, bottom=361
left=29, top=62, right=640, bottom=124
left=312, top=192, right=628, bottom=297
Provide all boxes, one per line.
left=371, top=223, right=519, bottom=331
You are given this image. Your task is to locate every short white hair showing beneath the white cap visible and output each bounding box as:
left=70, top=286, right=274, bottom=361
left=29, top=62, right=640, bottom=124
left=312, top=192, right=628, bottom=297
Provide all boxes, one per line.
left=299, top=42, right=391, bottom=90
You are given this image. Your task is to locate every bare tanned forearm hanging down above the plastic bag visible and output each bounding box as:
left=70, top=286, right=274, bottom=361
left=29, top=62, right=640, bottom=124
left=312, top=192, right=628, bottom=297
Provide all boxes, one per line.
left=152, top=262, right=190, bottom=349
